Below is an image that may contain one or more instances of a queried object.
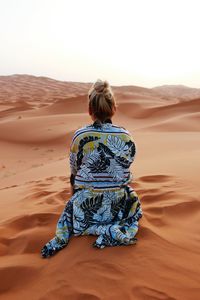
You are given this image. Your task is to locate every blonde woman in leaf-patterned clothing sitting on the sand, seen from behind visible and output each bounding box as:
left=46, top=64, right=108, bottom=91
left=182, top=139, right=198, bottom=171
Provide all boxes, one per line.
left=41, top=79, right=142, bottom=258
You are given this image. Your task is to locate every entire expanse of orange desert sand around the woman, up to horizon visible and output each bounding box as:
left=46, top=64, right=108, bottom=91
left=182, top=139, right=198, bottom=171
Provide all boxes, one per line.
left=0, top=75, right=200, bottom=300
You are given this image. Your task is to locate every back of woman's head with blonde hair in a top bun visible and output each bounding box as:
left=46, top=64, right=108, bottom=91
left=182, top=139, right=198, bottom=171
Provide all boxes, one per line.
left=88, top=79, right=116, bottom=122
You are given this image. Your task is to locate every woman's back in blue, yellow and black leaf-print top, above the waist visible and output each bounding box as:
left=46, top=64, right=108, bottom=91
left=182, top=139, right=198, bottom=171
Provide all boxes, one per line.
left=70, top=119, right=136, bottom=189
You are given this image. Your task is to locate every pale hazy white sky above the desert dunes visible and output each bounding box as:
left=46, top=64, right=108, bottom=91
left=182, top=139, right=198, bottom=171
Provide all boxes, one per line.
left=0, top=0, right=200, bottom=88
